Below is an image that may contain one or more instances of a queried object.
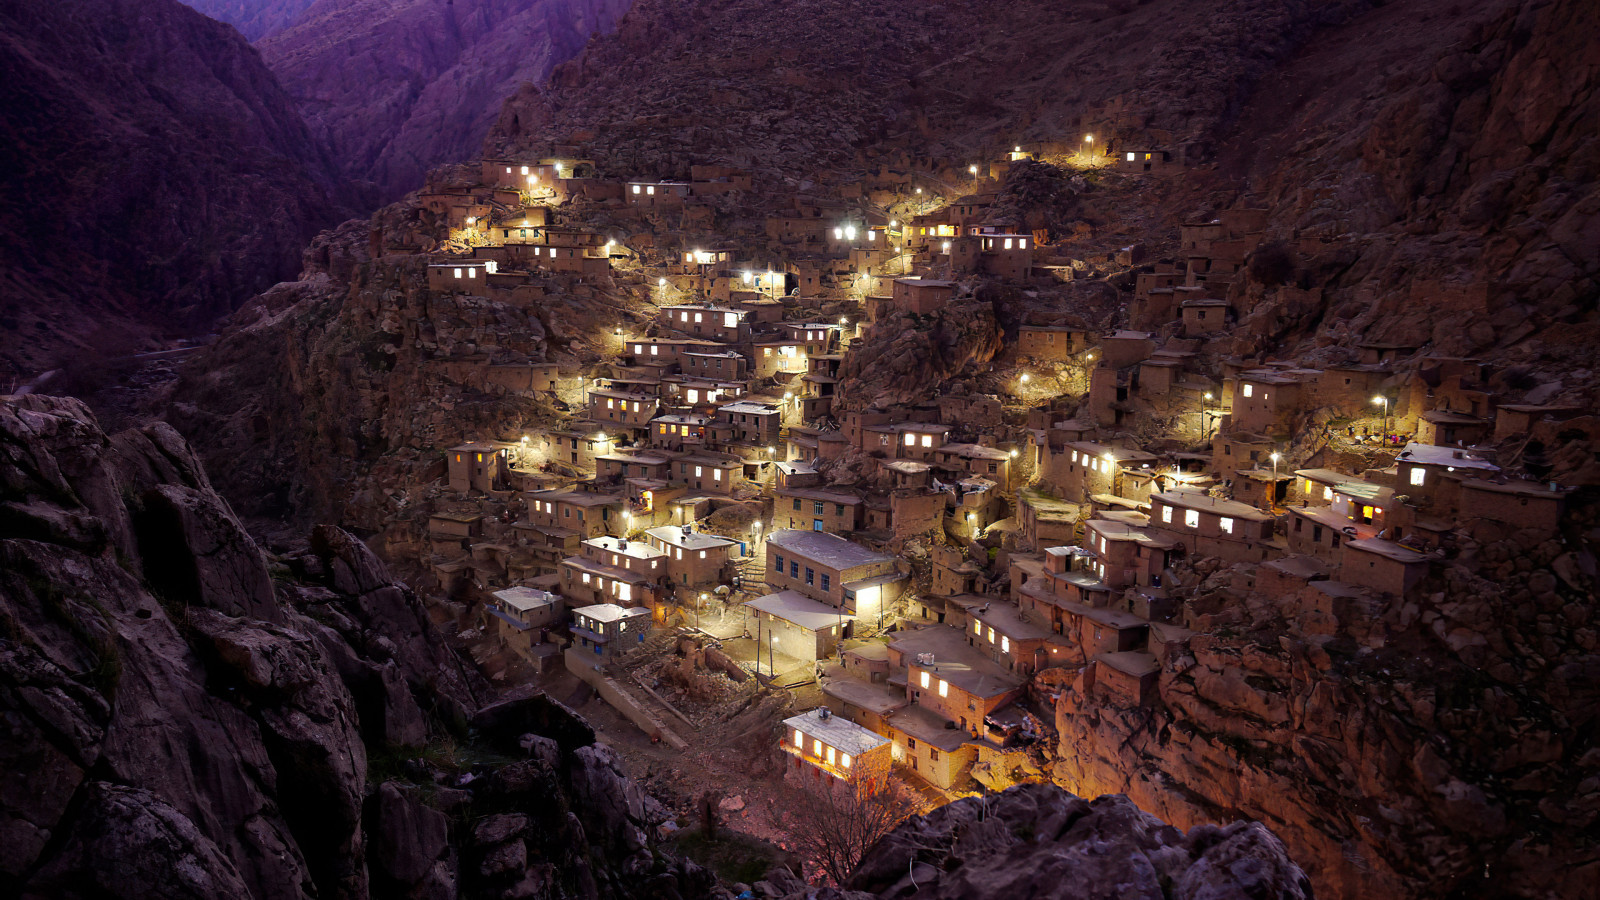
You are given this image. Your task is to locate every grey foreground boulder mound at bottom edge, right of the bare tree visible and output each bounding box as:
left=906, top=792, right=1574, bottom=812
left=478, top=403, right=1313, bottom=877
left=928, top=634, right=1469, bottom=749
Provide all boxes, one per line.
left=789, top=785, right=1312, bottom=900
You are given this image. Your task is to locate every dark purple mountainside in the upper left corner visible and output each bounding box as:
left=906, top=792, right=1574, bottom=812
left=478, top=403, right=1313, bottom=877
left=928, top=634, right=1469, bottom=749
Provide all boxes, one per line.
left=0, top=0, right=341, bottom=381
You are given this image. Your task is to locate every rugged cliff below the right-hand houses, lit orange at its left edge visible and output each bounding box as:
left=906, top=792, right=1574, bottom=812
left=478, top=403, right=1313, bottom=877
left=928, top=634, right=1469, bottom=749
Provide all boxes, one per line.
left=1053, top=500, right=1600, bottom=898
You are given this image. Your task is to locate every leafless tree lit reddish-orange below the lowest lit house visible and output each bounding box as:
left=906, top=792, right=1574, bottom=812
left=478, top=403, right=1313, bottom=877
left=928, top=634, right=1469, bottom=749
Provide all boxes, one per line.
left=784, top=759, right=923, bottom=884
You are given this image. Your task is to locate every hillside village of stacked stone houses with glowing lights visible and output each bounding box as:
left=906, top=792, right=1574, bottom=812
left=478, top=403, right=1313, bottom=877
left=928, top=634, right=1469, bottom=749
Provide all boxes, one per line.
left=373, top=135, right=1581, bottom=819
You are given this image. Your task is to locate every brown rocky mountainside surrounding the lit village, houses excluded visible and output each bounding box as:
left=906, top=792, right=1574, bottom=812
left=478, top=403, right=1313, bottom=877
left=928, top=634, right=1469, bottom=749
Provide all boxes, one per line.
left=162, top=0, right=1600, bottom=898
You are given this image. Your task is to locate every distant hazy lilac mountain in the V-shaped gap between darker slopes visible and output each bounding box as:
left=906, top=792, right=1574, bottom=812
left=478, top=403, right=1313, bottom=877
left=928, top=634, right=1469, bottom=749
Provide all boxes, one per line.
left=258, top=0, right=629, bottom=200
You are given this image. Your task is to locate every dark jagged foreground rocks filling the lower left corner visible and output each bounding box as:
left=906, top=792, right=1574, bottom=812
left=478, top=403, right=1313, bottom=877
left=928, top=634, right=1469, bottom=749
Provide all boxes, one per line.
left=0, top=396, right=714, bottom=900
